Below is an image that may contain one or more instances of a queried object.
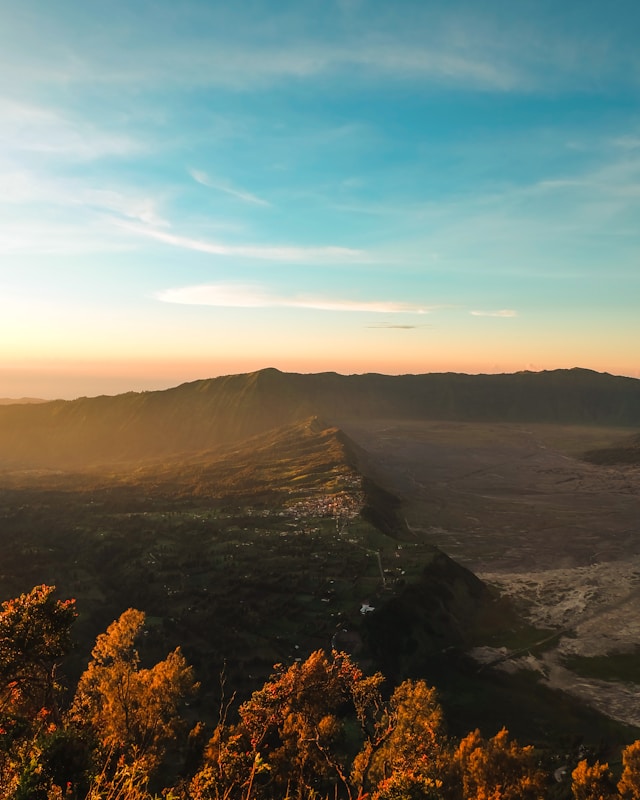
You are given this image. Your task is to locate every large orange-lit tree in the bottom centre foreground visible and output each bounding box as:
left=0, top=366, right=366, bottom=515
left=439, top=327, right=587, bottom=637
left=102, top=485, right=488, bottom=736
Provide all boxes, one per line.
left=191, top=650, right=383, bottom=800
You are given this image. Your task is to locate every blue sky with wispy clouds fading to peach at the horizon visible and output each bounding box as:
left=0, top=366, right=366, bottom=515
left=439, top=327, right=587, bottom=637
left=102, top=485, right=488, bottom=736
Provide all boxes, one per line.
left=0, top=0, right=640, bottom=398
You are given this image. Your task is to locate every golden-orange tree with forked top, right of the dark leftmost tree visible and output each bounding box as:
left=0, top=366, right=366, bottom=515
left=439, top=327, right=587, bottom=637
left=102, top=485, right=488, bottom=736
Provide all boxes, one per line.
left=71, top=608, right=197, bottom=769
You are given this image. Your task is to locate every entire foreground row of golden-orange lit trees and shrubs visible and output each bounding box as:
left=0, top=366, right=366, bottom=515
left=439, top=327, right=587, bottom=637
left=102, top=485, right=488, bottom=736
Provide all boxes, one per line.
left=0, top=586, right=640, bottom=800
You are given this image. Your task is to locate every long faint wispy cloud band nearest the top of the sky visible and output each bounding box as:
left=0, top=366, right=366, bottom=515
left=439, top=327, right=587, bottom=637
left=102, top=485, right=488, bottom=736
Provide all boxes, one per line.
left=3, top=37, right=523, bottom=91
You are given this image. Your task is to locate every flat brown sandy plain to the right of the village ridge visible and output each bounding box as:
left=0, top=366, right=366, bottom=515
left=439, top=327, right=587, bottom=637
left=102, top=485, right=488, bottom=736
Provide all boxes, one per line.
left=342, top=421, right=640, bottom=727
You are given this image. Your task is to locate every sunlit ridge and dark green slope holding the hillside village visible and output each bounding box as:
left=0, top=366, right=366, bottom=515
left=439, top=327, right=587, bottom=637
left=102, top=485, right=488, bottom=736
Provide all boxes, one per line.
left=0, top=418, right=508, bottom=712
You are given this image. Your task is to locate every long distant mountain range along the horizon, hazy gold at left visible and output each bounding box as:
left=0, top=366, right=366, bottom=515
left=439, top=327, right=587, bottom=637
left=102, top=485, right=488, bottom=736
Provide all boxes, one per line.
left=0, top=369, right=640, bottom=468
